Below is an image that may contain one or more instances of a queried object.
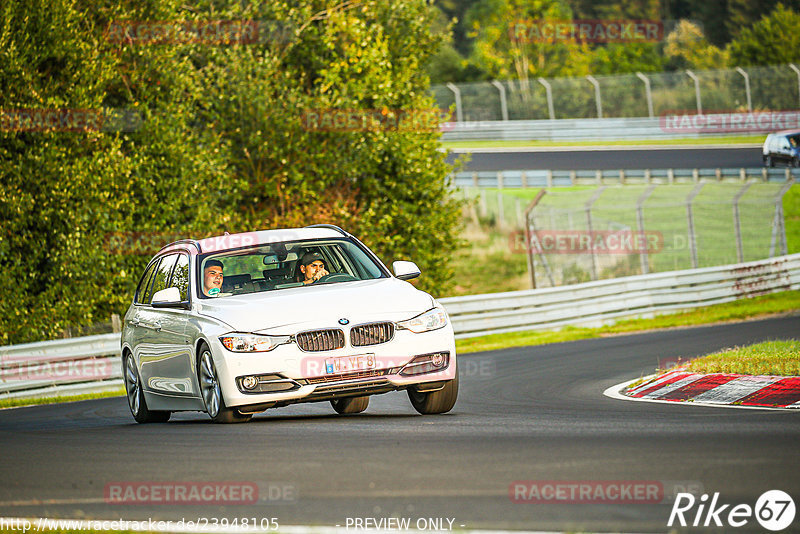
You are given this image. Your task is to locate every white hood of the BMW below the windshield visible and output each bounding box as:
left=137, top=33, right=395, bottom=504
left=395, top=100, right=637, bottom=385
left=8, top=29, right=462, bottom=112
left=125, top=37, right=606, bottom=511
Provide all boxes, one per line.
left=197, top=278, right=434, bottom=334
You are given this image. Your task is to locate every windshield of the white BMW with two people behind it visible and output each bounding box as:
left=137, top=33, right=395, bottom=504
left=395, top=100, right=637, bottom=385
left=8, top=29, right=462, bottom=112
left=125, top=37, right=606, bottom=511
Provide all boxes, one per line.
left=198, top=239, right=387, bottom=298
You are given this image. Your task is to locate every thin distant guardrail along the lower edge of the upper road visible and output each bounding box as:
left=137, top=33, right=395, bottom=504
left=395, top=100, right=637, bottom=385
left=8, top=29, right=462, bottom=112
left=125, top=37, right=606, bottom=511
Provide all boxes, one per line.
left=452, top=167, right=800, bottom=189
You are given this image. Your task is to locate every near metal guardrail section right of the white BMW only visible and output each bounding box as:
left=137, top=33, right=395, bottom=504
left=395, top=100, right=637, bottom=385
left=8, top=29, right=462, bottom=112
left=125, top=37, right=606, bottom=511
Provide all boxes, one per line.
left=440, top=254, right=800, bottom=338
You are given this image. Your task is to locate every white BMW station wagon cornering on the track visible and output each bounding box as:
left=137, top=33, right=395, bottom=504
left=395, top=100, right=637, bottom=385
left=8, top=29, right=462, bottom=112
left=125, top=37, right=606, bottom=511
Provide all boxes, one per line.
left=122, top=225, right=458, bottom=423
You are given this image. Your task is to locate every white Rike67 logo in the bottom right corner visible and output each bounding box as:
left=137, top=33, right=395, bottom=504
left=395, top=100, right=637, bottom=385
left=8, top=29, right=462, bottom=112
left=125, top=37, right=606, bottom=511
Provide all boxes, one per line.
left=667, top=490, right=795, bottom=532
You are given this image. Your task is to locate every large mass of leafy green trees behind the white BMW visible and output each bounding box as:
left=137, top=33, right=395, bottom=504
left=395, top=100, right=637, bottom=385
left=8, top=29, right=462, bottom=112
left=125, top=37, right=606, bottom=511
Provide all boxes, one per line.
left=0, top=0, right=459, bottom=343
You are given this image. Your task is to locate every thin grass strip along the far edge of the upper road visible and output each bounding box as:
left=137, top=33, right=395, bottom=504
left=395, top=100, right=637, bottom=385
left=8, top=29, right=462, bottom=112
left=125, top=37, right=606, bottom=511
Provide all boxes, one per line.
left=442, top=135, right=764, bottom=148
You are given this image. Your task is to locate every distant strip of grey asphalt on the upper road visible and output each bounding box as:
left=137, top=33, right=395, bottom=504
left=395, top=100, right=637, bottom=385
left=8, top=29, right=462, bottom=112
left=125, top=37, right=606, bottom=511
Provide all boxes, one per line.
left=448, top=147, right=763, bottom=171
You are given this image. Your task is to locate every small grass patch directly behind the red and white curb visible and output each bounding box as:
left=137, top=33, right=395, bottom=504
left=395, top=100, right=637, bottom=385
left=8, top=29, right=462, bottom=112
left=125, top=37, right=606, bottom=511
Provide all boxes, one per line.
left=686, top=339, right=800, bottom=376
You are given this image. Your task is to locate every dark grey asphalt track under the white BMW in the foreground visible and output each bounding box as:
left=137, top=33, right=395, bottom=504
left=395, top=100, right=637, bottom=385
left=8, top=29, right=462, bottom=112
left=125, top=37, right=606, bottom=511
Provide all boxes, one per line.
left=0, top=316, right=800, bottom=532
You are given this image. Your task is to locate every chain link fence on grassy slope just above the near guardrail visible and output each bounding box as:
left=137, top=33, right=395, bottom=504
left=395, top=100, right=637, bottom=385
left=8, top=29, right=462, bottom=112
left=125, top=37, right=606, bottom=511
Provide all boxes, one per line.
left=510, top=182, right=791, bottom=287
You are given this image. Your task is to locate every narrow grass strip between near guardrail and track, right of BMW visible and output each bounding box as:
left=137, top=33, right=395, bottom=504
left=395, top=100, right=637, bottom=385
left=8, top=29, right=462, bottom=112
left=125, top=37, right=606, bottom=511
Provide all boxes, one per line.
left=456, top=291, right=800, bottom=354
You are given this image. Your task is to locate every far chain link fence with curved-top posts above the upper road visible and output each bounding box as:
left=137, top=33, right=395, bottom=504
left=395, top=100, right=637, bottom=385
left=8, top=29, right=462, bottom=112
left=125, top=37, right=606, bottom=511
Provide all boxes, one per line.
left=431, top=64, right=800, bottom=122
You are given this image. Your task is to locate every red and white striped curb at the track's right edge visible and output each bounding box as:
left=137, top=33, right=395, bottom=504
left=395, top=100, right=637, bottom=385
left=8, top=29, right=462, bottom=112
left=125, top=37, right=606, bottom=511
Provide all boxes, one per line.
left=603, top=369, right=800, bottom=409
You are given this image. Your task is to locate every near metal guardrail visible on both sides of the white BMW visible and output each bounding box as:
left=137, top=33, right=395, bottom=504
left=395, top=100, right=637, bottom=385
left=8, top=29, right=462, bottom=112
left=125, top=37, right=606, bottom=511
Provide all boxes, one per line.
left=0, top=254, right=800, bottom=397
